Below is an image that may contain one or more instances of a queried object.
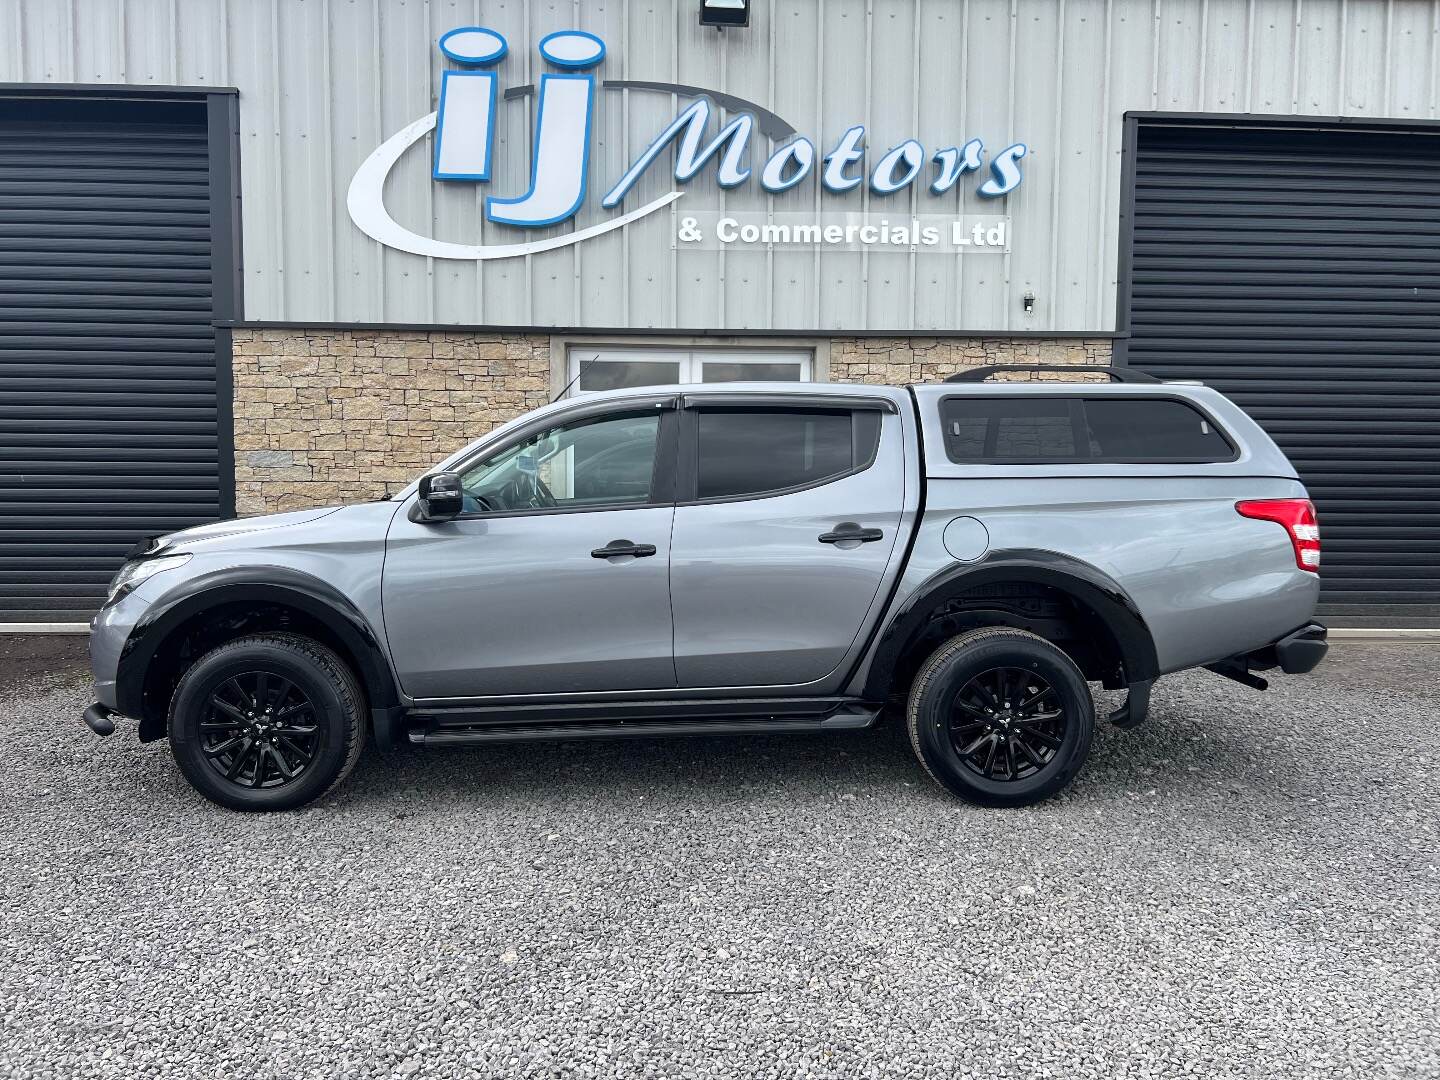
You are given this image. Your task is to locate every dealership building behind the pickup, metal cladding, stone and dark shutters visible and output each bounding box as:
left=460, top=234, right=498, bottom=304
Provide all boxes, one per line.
left=0, top=0, right=1440, bottom=626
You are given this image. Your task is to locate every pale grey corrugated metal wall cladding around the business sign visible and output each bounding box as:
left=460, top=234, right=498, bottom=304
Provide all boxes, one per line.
left=0, top=0, right=1440, bottom=333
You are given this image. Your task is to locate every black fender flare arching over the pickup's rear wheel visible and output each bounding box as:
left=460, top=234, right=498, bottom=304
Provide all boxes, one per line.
left=863, top=549, right=1159, bottom=700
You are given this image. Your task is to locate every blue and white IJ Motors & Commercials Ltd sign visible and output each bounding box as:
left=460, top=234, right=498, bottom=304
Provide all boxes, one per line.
left=347, top=26, right=1025, bottom=261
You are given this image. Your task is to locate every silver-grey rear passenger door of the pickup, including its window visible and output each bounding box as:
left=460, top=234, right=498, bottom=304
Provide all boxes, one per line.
left=670, top=393, right=906, bottom=688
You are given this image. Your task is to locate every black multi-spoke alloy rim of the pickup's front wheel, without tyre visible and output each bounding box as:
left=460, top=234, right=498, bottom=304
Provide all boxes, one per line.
left=200, top=671, right=324, bottom=788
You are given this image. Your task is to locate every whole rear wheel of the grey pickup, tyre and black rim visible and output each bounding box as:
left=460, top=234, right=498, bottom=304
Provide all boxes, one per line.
left=906, top=626, right=1094, bottom=806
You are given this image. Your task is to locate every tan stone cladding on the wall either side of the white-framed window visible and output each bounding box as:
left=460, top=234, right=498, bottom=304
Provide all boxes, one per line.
left=233, top=330, right=1110, bottom=514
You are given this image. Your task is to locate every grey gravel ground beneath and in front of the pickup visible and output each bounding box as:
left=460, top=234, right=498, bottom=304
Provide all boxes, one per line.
left=0, top=645, right=1440, bottom=1080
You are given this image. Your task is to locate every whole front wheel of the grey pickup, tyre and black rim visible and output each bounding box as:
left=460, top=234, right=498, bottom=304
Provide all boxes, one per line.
left=170, top=634, right=364, bottom=811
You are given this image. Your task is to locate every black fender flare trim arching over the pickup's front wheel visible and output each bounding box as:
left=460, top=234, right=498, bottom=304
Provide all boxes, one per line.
left=115, top=566, right=400, bottom=739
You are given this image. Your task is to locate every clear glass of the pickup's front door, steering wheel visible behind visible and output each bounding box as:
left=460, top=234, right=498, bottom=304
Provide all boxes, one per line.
left=461, top=410, right=660, bottom=513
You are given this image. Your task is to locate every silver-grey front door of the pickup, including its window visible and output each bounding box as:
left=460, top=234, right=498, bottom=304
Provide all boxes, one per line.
left=382, top=400, right=675, bottom=698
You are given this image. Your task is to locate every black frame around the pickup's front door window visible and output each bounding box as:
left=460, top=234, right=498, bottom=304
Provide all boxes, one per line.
left=426, top=395, right=680, bottom=521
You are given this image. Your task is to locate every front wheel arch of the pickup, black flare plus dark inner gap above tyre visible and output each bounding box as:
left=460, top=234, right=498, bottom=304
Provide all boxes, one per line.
left=115, top=566, right=400, bottom=742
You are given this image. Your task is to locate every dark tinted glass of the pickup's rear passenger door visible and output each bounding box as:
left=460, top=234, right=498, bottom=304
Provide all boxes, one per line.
left=697, top=409, right=880, bottom=498
